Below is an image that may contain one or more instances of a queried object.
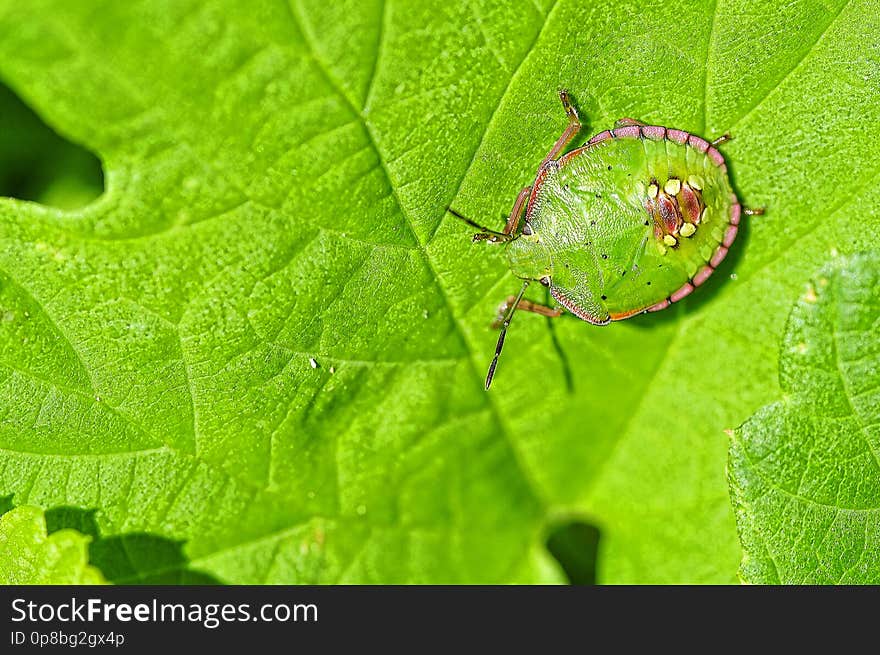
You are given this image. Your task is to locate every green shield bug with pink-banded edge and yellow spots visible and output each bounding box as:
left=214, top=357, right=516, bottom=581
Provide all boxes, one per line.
left=449, top=91, right=763, bottom=389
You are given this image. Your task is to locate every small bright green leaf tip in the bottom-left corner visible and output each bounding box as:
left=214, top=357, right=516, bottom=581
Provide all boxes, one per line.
left=0, top=505, right=105, bottom=585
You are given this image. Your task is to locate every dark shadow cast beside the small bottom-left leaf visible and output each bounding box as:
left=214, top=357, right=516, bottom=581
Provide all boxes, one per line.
left=46, top=506, right=222, bottom=585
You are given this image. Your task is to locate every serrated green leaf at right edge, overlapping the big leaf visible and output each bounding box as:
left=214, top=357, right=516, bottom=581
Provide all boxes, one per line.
left=730, top=253, right=880, bottom=584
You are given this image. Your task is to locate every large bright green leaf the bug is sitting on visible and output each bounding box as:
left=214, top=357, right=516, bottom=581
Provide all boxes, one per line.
left=0, top=0, right=880, bottom=583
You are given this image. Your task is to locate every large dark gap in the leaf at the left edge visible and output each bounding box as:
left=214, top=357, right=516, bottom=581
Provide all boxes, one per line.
left=0, top=82, right=104, bottom=210
